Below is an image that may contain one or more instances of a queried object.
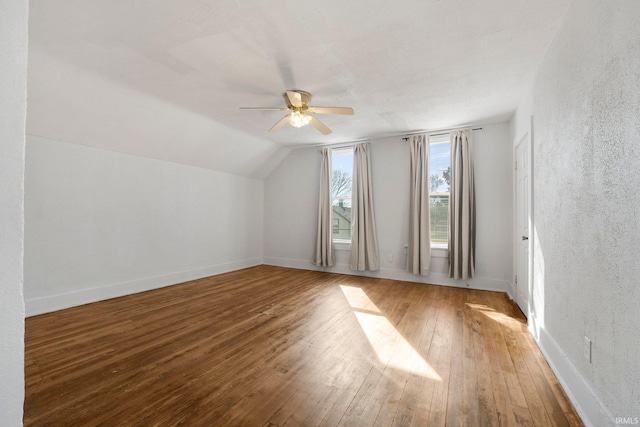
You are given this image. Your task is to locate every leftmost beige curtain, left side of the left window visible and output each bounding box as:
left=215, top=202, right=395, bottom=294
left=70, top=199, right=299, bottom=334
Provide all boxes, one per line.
left=311, top=148, right=334, bottom=267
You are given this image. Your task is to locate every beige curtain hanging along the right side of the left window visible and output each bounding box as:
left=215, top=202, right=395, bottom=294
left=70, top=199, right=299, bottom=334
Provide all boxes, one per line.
left=349, top=143, right=380, bottom=271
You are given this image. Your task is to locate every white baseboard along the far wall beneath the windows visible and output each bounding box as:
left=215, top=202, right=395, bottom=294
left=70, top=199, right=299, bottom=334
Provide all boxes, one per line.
left=264, top=257, right=510, bottom=294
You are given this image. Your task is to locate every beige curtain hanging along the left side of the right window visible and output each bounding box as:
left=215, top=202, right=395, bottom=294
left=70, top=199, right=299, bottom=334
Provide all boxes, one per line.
left=407, top=135, right=431, bottom=276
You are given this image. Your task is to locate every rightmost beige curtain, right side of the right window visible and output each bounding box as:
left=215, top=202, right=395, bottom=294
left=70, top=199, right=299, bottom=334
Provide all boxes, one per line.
left=449, top=130, right=476, bottom=280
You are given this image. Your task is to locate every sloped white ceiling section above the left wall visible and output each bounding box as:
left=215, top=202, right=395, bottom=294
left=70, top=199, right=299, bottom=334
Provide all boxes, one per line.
left=27, top=47, right=289, bottom=178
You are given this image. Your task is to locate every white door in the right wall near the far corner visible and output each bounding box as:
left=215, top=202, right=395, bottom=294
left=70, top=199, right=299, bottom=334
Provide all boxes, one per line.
left=515, top=134, right=531, bottom=317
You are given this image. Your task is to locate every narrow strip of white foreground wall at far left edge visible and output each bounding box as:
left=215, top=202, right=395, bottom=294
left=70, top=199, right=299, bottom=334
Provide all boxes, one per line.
left=0, top=0, right=28, bottom=426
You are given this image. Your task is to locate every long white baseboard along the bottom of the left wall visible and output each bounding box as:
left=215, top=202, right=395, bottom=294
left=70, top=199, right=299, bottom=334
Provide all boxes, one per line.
left=25, top=258, right=262, bottom=317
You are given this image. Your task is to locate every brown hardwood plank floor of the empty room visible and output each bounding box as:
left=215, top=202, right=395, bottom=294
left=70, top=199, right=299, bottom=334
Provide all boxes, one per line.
left=24, top=266, right=583, bottom=426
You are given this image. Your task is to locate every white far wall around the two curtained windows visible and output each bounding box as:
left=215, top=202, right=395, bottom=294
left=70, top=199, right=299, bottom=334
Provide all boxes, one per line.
left=264, top=123, right=513, bottom=291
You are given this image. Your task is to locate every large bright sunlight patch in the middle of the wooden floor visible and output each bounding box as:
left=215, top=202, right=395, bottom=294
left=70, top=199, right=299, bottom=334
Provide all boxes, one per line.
left=340, top=286, right=442, bottom=381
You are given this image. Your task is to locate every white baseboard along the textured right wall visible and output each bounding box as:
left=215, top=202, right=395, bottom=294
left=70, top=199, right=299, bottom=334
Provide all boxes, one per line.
left=529, top=322, right=616, bottom=427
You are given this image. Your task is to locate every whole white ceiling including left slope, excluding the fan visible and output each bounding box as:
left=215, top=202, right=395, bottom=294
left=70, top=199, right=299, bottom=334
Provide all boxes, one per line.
left=27, top=0, right=569, bottom=177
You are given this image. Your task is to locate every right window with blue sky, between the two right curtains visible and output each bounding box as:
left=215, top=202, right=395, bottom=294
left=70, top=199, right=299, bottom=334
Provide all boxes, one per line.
left=429, top=135, right=451, bottom=247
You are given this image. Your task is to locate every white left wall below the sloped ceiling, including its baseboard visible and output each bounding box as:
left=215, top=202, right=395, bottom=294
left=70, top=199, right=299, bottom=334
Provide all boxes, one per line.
left=24, top=135, right=264, bottom=315
